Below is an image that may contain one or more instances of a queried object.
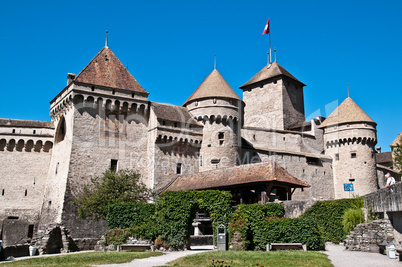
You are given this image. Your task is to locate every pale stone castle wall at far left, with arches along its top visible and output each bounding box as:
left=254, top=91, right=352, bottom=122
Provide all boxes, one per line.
left=0, top=125, right=54, bottom=226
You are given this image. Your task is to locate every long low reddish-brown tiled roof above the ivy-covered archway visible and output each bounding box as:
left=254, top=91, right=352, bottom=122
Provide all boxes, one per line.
left=165, top=162, right=310, bottom=191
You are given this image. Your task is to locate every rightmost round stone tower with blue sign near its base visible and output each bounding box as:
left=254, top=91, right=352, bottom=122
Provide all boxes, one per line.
left=319, top=97, right=377, bottom=199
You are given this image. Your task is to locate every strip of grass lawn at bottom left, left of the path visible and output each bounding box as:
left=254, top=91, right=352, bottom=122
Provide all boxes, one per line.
left=0, top=251, right=163, bottom=267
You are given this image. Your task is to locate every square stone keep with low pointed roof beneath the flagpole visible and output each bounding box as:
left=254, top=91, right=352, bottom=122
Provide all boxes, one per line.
left=240, top=62, right=306, bottom=130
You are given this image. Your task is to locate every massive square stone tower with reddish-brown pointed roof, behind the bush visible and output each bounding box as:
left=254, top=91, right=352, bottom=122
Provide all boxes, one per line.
left=40, top=46, right=150, bottom=238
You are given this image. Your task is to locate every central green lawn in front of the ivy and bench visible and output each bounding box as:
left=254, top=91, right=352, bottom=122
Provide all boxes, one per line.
left=170, top=251, right=333, bottom=267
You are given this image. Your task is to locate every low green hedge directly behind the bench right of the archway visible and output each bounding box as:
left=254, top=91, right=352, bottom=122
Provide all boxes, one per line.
left=253, top=218, right=325, bottom=250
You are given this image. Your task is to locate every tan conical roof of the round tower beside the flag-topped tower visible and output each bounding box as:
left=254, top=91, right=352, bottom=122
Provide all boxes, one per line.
left=183, top=70, right=241, bottom=106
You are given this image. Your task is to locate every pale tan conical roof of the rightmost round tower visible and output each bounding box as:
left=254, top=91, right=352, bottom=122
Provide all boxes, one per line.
left=319, top=97, right=377, bottom=128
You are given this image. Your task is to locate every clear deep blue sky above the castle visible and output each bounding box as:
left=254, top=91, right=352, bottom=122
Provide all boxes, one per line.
left=0, top=0, right=402, bottom=151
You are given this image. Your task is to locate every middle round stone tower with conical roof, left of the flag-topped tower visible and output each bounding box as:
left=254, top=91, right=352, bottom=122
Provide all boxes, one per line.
left=183, top=69, right=244, bottom=171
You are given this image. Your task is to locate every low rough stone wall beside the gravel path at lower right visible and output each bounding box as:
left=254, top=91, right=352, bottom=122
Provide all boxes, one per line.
left=344, top=220, right=394, bottom=253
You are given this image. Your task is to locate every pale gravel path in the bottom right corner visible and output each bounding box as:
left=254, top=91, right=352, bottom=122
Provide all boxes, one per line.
left=324, top=244, right=402, bottom=267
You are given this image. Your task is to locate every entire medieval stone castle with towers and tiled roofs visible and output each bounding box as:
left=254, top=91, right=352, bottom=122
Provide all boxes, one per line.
left=0, top=43, right=389, bottom=249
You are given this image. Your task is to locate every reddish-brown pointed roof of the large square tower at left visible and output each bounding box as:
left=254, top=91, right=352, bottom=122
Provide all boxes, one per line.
left=74, top=46, right=148, bottom=94
